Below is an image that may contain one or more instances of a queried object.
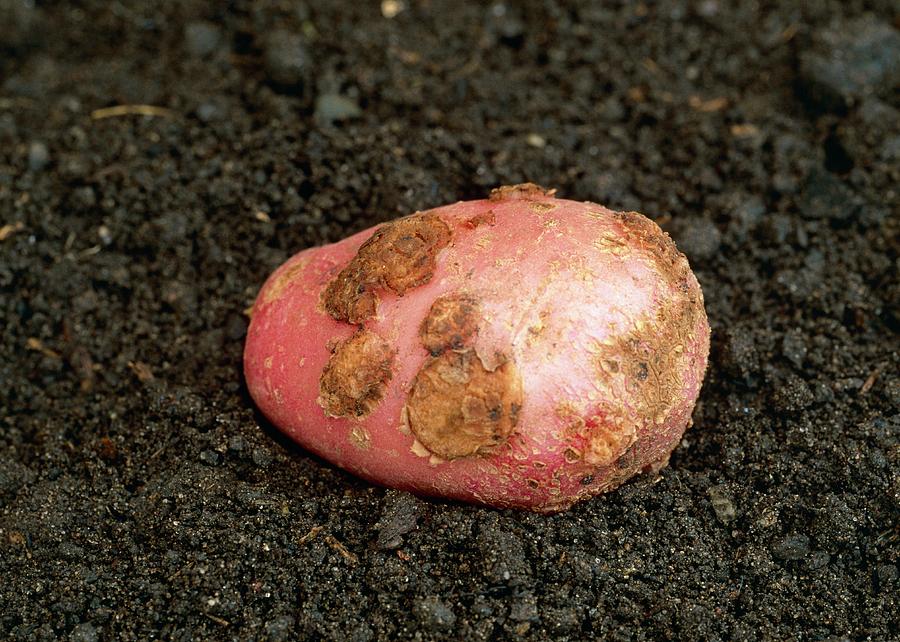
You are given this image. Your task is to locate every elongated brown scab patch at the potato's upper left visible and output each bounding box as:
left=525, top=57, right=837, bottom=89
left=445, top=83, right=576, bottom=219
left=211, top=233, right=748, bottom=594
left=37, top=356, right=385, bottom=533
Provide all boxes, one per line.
left=322, top=212, right=451, bottom=324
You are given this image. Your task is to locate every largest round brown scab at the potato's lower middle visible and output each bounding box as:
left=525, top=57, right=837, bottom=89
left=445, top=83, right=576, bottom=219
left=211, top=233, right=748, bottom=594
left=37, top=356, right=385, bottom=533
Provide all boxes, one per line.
left=407, top=350, right=523, bottom=459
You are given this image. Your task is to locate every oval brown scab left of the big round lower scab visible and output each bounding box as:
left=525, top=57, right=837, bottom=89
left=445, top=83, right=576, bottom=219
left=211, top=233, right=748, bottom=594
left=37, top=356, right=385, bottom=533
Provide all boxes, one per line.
left=318, top=330, right=394, bottom=419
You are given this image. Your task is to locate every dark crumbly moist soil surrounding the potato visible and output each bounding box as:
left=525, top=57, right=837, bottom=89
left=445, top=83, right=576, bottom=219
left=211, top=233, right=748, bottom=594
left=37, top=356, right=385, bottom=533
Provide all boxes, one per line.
left=0, top=0, right=900, bottom=642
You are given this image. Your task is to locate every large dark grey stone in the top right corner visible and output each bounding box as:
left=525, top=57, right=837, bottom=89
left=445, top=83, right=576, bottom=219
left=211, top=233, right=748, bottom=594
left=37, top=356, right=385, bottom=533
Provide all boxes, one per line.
left=800, top=15, right=900, bottom=112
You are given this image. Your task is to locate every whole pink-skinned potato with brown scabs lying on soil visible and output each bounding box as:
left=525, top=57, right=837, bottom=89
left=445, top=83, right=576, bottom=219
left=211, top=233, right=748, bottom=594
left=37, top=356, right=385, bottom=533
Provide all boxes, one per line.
left=244, top=184, right=709, bottom=512
